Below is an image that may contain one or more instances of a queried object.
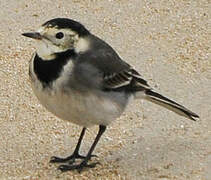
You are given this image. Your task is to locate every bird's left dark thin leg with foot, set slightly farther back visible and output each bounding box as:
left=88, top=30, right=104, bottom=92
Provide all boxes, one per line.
left=50, top=128, right=86, bottom=164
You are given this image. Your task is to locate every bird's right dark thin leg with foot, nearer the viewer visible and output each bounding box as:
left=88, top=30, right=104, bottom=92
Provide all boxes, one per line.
left=59, top=125, right=106, bottom=173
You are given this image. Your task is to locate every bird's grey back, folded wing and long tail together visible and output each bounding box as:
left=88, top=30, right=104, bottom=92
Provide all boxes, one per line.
left=70, top=35, right=199, bottom=120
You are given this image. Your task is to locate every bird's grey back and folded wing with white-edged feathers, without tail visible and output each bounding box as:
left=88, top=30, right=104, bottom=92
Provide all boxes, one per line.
left=76, top=34, right=151, bottom=91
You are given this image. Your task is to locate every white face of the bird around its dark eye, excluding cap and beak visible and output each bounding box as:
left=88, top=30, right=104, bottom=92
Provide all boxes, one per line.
left=34, top=27, right=89, bottom=60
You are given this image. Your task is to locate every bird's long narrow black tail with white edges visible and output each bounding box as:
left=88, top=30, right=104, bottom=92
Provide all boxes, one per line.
left=145, top=90, right=199, bottom=121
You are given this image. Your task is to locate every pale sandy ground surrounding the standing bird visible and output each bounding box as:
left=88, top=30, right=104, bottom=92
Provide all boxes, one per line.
left=0, top=0, right=211, bottom=180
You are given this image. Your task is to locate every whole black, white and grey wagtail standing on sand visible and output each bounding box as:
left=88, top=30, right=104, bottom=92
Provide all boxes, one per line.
left=23, top=18, right=199, bottom=172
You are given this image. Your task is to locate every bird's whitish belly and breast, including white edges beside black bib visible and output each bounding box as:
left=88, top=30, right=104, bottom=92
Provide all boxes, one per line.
left=30, top=57, right=128, bottom=127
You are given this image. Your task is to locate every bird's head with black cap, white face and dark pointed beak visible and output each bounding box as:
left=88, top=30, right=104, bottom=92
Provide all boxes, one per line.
left=22, top=18, right=90, bottom=60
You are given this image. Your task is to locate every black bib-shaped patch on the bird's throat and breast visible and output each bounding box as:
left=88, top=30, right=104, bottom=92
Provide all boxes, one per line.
left=34, top=50, right=76, bottom=87
